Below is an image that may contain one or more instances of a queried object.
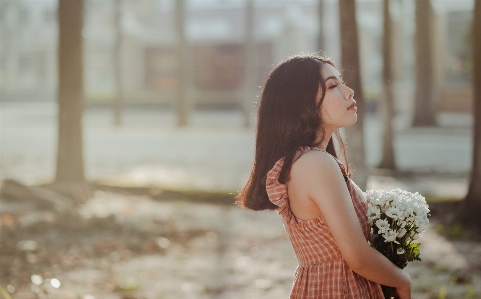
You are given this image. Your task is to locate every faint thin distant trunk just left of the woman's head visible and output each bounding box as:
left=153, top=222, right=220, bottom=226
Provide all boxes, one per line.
left=241, top=0, right=257, bottom=128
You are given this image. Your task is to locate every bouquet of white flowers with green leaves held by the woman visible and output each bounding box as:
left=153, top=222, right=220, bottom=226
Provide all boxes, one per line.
left=366, top=188, right=430, bottom=298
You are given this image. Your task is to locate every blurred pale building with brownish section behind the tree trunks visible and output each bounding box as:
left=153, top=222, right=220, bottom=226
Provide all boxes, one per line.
left=0, top=0, right=473, bottom=112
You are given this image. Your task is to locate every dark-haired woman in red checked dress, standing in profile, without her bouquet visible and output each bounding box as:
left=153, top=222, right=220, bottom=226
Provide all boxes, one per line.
left=238, top=55, right=411, bottom=299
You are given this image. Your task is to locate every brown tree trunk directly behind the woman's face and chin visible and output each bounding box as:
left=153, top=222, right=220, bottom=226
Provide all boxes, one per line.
left=339, top=0, right=367, bottom=189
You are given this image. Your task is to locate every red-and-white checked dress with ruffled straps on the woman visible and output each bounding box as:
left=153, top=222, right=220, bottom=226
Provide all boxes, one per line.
left=266, top=147, right=384, bottom=299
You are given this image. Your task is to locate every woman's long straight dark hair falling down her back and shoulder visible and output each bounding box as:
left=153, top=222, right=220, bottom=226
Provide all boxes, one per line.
left=237, top=55, right=349, bottom=211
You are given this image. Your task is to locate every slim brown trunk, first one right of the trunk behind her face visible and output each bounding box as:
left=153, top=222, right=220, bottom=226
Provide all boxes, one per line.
left=379, top=0, right=396, bottom=169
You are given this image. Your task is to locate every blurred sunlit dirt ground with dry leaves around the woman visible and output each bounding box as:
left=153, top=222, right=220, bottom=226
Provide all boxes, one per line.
left=0, top=191, right=481, bottom=299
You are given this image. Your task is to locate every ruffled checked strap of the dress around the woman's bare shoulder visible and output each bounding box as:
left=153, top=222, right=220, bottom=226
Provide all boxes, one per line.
left=266, top=146, right=348, bottom=221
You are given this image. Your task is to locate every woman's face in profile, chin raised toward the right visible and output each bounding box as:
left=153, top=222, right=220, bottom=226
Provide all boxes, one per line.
left=318, top=63, right=357, bottom=132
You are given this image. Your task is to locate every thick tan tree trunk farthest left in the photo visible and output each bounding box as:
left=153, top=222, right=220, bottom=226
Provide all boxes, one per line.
left=55, top=0, right=85, bottom=182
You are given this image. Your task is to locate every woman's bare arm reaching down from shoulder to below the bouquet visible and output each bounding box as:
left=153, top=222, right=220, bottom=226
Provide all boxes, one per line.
left=289, top=152, right=411, bottom=298
